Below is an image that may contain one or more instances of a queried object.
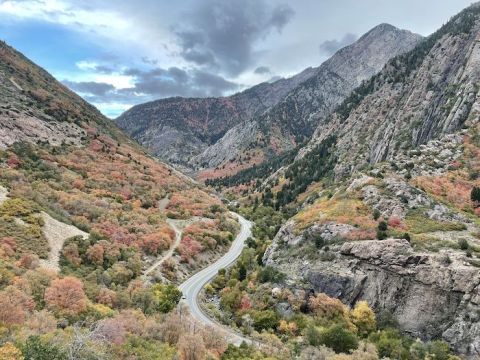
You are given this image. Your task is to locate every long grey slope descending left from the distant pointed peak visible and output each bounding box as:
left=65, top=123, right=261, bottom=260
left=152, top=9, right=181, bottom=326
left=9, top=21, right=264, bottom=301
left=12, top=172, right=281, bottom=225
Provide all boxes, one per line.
left=196, top=24, right=422, bottom=177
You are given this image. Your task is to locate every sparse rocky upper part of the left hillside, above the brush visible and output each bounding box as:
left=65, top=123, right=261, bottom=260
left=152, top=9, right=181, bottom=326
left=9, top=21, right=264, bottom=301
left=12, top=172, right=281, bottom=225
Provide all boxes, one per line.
left=0, top=42, right=126, bottom=148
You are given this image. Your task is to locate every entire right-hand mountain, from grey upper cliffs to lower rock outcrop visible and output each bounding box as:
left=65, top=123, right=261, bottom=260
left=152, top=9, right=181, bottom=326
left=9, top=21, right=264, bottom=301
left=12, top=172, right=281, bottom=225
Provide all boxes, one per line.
left=255, top=4, right=480, bottom=357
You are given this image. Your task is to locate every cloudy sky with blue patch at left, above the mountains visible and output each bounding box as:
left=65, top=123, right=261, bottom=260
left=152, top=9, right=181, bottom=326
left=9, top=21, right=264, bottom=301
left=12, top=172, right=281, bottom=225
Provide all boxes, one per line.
left=0, top=0, right=471, bottom=117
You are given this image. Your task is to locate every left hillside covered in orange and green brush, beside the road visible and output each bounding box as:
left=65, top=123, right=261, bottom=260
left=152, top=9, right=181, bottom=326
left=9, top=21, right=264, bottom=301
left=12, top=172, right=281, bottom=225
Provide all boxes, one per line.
left=0, top=43, right=242, bottom=359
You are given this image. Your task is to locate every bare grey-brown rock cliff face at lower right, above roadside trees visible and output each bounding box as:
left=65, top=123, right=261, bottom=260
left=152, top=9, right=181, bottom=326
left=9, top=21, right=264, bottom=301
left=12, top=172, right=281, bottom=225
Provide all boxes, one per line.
left=264, top=225, right=480, bottom=355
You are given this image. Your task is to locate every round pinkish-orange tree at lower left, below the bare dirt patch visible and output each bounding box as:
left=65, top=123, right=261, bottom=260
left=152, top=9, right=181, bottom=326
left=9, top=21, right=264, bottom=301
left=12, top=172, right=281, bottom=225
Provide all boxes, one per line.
left=45, top=276, right=87, bottom=316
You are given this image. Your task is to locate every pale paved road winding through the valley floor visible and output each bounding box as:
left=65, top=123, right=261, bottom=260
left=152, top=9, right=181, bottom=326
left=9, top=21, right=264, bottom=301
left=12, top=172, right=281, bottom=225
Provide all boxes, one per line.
left=179, top=213, right=252, bottom=345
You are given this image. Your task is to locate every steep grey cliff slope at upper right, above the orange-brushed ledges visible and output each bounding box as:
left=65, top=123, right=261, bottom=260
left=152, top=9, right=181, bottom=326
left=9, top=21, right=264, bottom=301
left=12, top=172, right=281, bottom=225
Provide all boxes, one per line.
left=300, top=5, right=480, bottom=176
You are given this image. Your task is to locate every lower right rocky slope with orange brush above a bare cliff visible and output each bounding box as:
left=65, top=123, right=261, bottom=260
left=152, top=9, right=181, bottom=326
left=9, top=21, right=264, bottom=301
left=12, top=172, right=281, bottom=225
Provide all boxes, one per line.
left=264, top=128, right=480, bottom=356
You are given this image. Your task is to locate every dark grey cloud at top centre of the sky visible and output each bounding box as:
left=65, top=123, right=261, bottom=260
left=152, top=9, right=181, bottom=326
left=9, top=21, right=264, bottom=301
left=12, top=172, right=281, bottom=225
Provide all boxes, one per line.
left=173, top=0, right=294, bottom=76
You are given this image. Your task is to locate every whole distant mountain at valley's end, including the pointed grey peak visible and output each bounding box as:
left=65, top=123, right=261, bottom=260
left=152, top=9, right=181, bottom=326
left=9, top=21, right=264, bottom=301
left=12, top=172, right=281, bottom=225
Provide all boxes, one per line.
left=117, top=24, right=421, bottom=178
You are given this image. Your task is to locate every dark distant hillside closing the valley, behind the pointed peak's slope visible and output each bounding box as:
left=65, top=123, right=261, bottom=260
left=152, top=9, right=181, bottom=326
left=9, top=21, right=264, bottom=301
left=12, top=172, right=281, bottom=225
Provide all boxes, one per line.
left=116, top=69, right=315, bottom=166
